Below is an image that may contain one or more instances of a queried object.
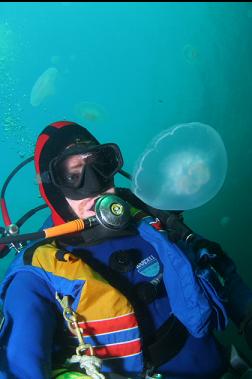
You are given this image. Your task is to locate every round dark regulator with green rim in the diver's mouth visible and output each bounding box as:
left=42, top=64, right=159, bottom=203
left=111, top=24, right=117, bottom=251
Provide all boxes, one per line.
left=95, top=195, right=130, bottom=230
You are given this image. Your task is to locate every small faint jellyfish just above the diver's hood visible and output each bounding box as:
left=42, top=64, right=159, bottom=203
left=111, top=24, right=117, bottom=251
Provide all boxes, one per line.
left=75, top=101, right=106, bottom=122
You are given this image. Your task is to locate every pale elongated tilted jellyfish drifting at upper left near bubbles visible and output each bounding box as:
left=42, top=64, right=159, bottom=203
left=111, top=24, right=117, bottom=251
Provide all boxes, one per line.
left=30, top=67, right=58, bottom=107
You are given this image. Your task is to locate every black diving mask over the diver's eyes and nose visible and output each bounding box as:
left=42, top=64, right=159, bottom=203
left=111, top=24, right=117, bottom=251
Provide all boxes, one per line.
left=49, top=143, right=123, bottom=200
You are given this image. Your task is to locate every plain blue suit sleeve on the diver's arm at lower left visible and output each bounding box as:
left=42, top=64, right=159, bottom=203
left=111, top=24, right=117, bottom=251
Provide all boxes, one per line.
left=0, top=272, right=57, bottom=379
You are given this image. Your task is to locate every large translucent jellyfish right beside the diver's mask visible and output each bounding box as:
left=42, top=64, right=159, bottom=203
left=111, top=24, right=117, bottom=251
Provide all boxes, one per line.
left=132, top=122, right=227, bottom=210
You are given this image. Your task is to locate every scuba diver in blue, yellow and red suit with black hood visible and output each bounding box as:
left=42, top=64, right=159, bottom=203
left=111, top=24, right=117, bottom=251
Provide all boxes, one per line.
left=0, top=121, right=252, bottom=379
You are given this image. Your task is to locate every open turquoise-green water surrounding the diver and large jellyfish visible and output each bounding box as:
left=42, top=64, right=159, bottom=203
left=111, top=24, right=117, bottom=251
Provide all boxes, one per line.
left=0, top=2, right=252, bottom=362
